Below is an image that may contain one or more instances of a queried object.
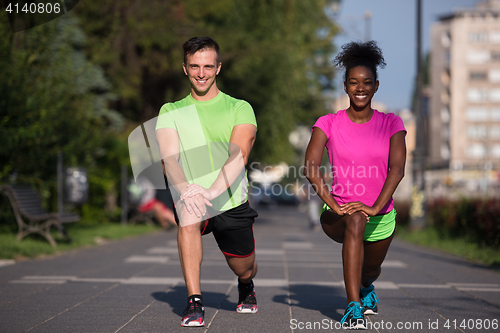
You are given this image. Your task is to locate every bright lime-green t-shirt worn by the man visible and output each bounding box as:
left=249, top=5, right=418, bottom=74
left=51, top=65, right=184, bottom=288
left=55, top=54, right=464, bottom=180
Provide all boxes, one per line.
left=156, top=91, right=257, bottom=211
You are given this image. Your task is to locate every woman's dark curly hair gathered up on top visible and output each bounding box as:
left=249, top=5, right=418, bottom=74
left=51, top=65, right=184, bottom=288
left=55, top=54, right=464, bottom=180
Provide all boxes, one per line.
left=333, top=40, right=386, bottom=81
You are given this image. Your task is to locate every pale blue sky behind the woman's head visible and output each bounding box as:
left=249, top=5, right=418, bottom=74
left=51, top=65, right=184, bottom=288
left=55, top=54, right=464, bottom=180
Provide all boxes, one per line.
left=334, top=0, right=481, bottom=111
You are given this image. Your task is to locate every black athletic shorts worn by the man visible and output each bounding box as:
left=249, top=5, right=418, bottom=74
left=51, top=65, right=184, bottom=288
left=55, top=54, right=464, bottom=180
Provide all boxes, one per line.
left=174, top=201, right=258, bottom=258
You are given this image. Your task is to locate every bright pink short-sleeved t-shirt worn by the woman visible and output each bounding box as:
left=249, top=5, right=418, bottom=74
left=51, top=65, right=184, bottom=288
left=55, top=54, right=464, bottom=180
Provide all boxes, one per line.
left=313, top=110, right=406, bottom=214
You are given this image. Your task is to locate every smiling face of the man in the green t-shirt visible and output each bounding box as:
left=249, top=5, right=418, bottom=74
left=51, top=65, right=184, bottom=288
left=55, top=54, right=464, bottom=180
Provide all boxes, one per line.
left=182, top=49, right=221, bottom=101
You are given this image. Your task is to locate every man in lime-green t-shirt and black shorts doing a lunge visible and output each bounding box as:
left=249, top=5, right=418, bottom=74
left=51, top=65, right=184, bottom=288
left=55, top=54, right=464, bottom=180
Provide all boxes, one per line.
left=156, top=37, right=257, bottom=326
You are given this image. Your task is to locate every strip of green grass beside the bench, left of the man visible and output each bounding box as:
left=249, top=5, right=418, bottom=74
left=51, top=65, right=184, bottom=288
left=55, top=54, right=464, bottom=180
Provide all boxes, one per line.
left=0, top=223, right=161, bottom=260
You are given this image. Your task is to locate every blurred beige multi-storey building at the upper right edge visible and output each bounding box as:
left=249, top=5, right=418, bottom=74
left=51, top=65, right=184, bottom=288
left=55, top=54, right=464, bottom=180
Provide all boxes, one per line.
left=427, top=0, right=500, bottom=170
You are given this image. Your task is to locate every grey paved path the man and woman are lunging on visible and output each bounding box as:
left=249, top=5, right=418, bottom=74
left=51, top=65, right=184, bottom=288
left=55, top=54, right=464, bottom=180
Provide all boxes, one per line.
left=0, top=209, right=500, bottom=333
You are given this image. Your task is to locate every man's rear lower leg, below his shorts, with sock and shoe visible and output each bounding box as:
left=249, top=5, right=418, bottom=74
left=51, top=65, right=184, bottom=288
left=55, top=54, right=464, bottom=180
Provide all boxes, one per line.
left=226, top=253, right=257, bottom=313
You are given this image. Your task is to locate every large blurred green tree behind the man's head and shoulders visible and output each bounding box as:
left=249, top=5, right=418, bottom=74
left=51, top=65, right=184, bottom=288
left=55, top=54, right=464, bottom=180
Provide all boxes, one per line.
left=76, top=0, right=337, bottom=163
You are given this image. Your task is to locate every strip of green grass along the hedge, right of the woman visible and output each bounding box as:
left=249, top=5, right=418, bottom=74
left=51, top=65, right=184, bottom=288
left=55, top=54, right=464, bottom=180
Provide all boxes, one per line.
left=396, top=226, right=500, bottom=269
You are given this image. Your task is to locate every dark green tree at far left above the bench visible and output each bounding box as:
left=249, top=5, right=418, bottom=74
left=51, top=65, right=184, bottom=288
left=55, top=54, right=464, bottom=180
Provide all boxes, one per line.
left=0, top=13, right=127, bottom=217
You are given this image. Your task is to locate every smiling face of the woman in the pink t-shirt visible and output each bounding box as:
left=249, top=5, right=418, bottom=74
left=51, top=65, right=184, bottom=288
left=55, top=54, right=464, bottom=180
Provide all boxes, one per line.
left=344, top=66, right=378, bottom=111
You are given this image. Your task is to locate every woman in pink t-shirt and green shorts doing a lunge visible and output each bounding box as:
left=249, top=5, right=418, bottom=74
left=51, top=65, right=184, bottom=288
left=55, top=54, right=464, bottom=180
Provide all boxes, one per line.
left=305, top=41, right=406, bottom=329
